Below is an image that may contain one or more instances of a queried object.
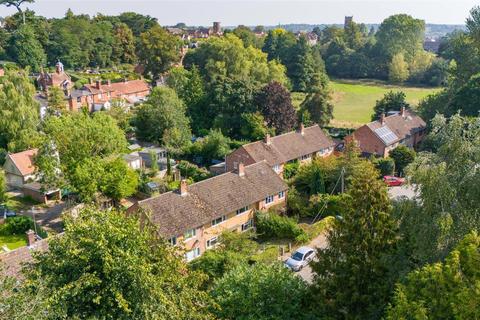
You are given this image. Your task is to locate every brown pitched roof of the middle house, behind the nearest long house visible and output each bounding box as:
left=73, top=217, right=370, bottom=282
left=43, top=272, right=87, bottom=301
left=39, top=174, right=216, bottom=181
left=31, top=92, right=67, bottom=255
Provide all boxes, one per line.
left=242, top=125, right=335, bottom=165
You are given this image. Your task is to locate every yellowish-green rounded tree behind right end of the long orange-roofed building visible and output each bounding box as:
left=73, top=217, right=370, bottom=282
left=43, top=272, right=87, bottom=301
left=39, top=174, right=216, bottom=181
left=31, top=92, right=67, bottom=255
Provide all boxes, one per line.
left=138, top=25, right=180, bottom=79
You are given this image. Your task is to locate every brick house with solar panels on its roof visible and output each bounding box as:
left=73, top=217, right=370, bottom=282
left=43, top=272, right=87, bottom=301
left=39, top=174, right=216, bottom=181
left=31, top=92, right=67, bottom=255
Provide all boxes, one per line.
left=346, top=108, right=427, bottom=157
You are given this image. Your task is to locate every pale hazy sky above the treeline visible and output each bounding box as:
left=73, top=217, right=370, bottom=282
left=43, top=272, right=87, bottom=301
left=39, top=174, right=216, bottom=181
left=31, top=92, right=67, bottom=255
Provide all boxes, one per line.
left=0, top=0, right=479, bottom=26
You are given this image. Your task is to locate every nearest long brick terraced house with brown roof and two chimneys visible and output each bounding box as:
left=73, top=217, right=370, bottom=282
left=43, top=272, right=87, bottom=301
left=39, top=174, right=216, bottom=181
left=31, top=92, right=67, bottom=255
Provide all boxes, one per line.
left=127, top=161, right=288, bottom=261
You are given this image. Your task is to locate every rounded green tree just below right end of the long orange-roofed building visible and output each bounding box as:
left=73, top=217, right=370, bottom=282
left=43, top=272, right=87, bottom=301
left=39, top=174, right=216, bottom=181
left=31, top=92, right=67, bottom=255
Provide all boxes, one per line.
left=134, top=87, right=191, bottom=145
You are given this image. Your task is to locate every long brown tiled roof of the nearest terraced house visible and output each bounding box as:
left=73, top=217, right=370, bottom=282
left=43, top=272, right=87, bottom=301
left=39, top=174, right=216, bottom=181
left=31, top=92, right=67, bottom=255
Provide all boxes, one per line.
left=138, top=162, right=288, bottom=237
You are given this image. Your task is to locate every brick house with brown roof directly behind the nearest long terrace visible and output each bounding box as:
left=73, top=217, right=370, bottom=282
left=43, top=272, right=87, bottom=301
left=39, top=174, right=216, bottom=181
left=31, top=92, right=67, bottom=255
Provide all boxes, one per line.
left=225, top=124, right=335, bottom=175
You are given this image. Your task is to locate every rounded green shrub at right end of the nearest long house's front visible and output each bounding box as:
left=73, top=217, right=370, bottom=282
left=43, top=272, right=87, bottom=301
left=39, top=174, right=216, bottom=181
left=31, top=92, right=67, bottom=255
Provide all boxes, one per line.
left=256, top=212, right=308, bottom=242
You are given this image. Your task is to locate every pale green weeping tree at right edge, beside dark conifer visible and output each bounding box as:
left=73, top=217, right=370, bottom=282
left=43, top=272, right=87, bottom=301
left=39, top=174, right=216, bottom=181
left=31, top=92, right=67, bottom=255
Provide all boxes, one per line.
left=404, top=115, right=480, bottom=263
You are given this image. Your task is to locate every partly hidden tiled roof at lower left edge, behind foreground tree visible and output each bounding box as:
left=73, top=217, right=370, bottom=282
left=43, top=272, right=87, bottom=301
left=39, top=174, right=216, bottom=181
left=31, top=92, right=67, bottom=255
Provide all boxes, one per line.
left=0, top=239, right=48, bottom=277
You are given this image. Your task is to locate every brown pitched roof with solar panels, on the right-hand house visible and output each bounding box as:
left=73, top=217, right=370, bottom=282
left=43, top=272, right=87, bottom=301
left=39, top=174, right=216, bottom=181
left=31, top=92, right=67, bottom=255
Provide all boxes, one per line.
left=367, top=110, right=426, bottom=146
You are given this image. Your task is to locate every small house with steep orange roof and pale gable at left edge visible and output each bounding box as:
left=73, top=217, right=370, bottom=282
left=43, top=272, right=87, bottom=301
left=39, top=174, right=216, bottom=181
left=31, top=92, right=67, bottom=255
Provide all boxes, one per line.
left=3, top=149, right=38, bottom=188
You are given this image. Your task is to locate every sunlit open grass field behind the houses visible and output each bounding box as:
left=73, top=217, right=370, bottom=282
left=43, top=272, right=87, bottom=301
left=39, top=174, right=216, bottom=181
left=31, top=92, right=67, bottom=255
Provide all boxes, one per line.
left=292, top=80, right=440, bottom=128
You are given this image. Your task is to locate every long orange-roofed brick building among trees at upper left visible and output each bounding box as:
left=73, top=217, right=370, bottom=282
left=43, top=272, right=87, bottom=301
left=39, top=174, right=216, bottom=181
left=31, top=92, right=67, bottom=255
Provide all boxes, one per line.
left=68, top=80, right=150, bottom=112
